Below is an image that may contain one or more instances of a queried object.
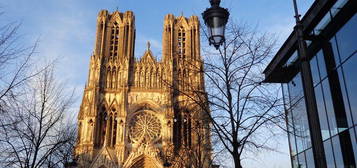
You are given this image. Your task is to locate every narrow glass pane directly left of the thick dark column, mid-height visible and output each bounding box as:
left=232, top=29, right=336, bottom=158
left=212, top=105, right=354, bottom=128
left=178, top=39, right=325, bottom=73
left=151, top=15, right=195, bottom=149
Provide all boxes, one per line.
left=322, top=79, right=337, bottom=136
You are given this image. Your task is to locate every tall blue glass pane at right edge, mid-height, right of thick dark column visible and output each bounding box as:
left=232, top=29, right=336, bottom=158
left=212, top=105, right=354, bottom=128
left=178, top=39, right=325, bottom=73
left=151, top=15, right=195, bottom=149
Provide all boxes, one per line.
left=343, top=53, right=357, bottom=124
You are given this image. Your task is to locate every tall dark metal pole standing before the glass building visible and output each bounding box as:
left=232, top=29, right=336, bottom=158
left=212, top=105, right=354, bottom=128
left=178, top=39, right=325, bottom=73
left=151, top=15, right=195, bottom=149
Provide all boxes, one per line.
left=293, top=0, right=327, bottom=168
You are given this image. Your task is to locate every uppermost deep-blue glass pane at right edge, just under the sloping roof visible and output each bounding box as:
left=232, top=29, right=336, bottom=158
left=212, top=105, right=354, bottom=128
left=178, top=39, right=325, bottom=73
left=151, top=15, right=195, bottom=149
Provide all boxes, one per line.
left=336, top=15, right=357, bottom=62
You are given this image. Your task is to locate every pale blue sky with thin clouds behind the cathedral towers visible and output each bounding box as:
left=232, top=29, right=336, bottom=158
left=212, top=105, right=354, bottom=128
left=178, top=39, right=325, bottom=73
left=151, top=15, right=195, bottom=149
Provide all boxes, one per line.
left=0, top=0, right=313, bottom=168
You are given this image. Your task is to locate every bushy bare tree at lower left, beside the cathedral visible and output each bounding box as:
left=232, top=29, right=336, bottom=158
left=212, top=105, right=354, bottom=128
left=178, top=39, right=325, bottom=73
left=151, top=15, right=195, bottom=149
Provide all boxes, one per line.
left=0, top=67, right=76, bottom=168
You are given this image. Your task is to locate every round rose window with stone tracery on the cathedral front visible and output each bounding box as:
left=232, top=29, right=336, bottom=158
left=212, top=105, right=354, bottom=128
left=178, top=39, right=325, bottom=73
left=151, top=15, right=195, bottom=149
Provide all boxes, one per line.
left=129, top=112, right=161, bottom=142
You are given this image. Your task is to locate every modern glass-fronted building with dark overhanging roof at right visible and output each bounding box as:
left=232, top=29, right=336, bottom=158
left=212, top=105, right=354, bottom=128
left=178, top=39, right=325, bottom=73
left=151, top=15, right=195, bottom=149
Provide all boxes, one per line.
left=264, top=0, right=357, bottom=168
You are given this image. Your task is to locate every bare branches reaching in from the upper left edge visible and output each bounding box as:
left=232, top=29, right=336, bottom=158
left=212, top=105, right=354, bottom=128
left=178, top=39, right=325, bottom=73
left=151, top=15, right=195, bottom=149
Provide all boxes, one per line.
left=0, top=13, right=39, bottom=112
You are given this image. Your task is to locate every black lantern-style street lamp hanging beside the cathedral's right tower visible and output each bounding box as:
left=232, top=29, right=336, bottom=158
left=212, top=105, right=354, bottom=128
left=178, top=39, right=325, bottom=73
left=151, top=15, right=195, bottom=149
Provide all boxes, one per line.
left=202, top=0, right=229, bottom=50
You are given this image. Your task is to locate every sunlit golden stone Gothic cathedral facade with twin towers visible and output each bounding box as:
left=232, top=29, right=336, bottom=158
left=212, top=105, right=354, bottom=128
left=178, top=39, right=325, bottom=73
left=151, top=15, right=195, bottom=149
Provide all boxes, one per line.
left=75, top=10, right=211, bottom=168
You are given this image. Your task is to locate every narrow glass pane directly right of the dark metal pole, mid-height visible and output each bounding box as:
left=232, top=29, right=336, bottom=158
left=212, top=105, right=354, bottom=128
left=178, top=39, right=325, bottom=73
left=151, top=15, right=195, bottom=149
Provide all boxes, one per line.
left=315, top=85, right=330, bottom=140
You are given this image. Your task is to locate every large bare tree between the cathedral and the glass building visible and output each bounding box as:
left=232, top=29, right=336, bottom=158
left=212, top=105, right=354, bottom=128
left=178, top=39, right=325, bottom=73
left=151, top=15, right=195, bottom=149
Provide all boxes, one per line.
left=173, top=22, right=285, bottom=168
